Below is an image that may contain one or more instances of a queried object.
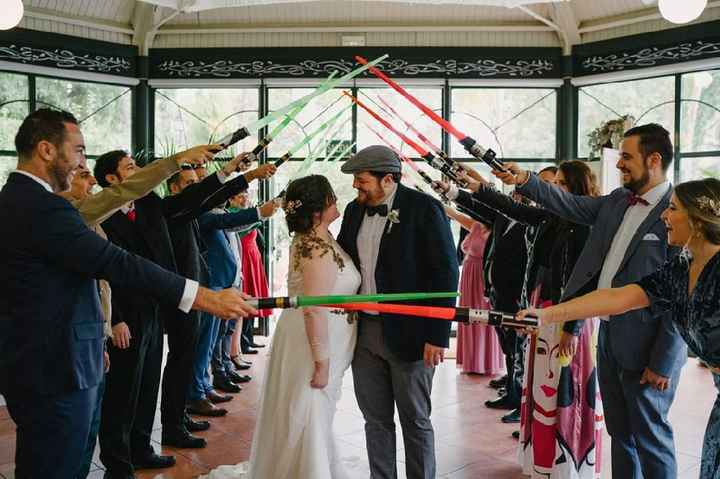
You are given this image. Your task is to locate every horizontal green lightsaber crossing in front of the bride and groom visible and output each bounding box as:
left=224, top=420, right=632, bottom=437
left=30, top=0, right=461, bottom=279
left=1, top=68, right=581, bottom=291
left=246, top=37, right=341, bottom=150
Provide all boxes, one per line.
left=247, top=291, right=460, bottom=309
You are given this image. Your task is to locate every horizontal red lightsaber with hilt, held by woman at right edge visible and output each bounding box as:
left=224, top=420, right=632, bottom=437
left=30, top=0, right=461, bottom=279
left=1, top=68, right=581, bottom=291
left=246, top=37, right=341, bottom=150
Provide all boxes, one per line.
left=323, top=302, right=540, bottom=329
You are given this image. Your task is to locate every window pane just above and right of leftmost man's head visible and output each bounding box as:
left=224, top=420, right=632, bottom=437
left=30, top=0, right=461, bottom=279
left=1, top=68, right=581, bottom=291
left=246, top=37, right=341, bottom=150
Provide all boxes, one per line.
left=36, top=77, right=132, bottom=155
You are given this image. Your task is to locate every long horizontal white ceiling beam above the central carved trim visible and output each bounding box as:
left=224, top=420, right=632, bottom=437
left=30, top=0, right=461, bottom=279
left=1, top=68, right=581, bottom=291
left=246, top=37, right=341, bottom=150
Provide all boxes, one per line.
left=157, top=23, right=554, bottom=35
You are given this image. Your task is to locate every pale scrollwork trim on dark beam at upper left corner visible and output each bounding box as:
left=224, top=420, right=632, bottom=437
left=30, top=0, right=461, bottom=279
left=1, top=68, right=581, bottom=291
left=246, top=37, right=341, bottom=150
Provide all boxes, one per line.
left=0, top=44, right=134, bottom=75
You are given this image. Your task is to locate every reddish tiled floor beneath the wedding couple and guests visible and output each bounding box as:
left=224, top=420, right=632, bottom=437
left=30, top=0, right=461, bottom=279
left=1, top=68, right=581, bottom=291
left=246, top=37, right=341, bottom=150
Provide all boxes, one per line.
left=0, top=348, right=715, bottom=479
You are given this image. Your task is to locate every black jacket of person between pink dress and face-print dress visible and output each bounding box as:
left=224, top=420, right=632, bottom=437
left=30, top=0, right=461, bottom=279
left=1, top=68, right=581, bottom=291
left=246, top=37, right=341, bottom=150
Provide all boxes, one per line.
left=455, top=191, right=527, bottom=313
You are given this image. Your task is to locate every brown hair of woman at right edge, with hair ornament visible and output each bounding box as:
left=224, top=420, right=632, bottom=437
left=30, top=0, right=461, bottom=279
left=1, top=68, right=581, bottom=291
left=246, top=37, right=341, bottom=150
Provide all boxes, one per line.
left=675, top=178, right=720, bottom=245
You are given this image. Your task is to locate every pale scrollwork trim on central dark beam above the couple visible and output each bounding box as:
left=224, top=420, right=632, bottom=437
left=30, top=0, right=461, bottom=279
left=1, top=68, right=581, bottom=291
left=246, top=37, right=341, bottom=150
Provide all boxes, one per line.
left=156, top=58, right=558, bottom=78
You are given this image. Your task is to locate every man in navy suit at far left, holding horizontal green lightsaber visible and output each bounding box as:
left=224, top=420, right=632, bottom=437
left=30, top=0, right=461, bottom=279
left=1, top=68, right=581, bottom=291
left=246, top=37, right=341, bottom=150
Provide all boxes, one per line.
left=0, top=109, right=254, bottom=479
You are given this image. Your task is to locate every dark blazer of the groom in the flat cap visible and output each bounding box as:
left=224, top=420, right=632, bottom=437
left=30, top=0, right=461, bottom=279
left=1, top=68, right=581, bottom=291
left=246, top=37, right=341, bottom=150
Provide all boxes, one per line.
left=338, top=185, right=458, bottom=361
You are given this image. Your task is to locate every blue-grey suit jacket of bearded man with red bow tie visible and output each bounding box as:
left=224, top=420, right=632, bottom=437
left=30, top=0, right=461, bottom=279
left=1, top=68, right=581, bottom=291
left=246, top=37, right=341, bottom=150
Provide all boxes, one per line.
left=518, top=175, right=687, bottom=377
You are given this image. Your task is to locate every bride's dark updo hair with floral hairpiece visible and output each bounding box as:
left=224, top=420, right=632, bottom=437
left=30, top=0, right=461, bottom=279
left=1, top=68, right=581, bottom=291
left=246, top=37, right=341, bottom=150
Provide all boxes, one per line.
left=283, top=175, right=337, bottom=233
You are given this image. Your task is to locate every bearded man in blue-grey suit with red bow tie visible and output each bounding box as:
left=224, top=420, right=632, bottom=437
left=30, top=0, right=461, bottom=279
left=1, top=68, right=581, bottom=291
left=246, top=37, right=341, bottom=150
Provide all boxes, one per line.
left=495, top=124, right=687, bottom=479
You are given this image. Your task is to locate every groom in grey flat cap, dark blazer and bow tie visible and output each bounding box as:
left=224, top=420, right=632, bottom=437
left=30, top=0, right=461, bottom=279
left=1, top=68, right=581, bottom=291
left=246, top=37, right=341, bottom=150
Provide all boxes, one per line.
left=338, top=146, right=458, bottom=479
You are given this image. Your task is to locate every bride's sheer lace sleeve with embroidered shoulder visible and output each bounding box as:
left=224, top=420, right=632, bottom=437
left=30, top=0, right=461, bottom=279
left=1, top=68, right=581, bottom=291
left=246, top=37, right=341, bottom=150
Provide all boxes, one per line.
left=293, top=236, right=342, bottom=361
